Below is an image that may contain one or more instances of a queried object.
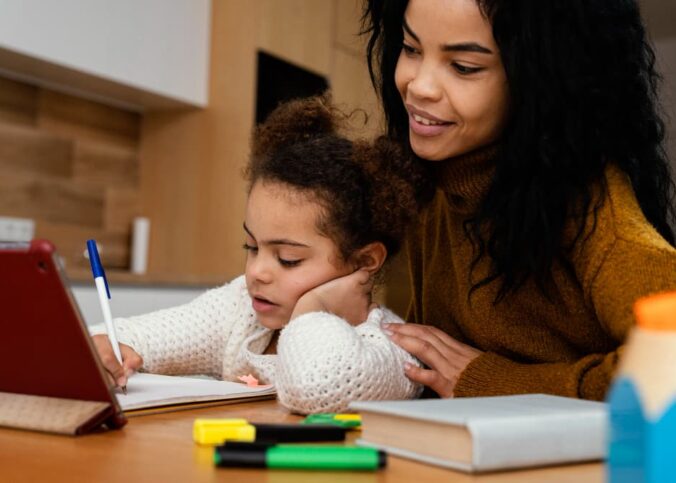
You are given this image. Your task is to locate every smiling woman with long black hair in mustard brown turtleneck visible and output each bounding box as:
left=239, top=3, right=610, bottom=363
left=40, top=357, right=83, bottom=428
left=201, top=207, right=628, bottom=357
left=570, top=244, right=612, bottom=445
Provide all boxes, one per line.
left=354, top=0, right=676, bottom=399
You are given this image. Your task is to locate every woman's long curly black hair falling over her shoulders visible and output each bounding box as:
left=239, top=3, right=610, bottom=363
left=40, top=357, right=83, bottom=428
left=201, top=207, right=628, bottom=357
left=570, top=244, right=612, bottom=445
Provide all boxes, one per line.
left=362, top=0, right=674, bottom=300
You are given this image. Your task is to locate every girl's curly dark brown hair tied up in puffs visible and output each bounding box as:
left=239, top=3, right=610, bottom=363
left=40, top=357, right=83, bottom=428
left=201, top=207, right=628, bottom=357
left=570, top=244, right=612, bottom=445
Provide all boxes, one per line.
left=245, top=95, right=425, bottom=260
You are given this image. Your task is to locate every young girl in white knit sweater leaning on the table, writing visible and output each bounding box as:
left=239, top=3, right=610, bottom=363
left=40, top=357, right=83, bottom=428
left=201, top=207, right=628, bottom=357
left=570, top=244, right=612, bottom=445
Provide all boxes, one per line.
left=92, top=98, right=420, bottom=413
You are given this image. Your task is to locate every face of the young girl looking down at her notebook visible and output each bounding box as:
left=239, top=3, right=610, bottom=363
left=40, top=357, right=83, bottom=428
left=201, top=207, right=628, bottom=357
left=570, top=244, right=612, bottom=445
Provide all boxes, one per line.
left=244, top=181, right=352, bottom=329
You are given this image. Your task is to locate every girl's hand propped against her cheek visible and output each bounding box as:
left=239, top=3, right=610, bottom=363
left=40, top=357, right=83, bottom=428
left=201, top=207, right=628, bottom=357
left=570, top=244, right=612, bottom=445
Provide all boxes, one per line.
left=291, top=269, right=373, bottom=325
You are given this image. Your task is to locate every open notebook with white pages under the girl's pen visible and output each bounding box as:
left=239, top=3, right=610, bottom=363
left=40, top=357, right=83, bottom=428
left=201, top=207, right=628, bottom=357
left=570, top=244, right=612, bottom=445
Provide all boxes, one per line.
left=116, top=373, right=275, bottom=411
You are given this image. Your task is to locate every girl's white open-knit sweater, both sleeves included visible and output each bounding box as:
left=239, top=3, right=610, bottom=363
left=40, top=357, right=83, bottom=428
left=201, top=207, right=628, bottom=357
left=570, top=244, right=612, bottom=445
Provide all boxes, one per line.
left=90, top=276, right=422, bottom=414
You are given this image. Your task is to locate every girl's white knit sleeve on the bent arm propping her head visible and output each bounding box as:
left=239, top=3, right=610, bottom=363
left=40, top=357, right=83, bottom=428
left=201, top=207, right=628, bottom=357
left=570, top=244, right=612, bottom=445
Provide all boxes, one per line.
left=275, top=309, right=421, bottom=414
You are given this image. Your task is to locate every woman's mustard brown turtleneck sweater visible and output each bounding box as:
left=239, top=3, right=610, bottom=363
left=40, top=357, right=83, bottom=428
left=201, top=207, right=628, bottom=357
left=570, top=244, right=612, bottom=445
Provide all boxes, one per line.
left=407, top=149, right=676, bottom=400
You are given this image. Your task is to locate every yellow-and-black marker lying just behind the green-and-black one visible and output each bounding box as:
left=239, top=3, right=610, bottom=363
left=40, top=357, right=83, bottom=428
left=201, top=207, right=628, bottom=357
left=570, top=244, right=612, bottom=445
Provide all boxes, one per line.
left=193, top=418, right=346, bottom=445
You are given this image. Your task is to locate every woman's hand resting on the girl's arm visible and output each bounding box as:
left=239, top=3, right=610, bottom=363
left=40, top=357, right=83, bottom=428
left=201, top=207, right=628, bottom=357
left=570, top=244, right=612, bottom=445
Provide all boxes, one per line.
left=382, top=324, right=482, bottom=397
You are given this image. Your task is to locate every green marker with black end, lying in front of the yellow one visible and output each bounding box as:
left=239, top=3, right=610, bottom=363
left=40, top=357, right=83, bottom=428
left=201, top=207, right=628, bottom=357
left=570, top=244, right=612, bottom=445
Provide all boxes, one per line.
left=214, top=443, right=387, bottom=471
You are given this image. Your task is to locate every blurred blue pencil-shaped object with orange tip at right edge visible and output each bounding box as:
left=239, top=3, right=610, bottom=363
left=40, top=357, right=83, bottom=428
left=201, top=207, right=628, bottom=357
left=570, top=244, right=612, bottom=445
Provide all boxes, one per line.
left=608, top=292, right=676, bottom=483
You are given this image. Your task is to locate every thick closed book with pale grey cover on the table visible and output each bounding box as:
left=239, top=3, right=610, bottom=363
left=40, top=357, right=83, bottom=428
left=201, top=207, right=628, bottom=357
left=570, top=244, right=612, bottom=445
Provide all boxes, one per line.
left=350, top=394, right=608, bottom=472
